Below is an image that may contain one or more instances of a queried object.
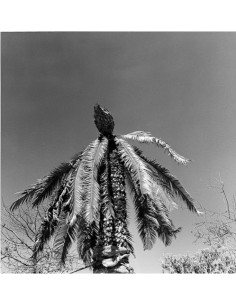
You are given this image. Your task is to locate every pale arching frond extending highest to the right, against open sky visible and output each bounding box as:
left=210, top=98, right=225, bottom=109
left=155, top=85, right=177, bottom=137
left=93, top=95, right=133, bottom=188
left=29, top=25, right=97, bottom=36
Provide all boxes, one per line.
left=121, top=131, right=190, bottom=165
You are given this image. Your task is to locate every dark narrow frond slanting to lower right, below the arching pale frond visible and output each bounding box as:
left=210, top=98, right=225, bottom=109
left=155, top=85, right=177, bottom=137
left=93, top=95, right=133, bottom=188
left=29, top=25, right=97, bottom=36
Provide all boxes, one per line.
left=134, top=147, right=198, bottom=213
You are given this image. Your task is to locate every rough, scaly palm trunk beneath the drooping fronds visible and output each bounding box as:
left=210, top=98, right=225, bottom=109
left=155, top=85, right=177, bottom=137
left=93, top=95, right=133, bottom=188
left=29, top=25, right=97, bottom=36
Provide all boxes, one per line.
left=93, top=148, right=133, bottom=273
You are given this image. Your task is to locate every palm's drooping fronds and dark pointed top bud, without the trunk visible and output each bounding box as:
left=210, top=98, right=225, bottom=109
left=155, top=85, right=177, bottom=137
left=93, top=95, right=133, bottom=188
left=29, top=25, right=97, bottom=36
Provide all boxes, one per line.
left=11, top=104, right=198, bottom=263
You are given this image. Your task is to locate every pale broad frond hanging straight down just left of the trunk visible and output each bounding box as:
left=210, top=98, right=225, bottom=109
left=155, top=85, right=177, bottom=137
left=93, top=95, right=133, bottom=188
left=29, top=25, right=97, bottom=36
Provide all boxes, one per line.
left=74, top=137, right=108, bottom=222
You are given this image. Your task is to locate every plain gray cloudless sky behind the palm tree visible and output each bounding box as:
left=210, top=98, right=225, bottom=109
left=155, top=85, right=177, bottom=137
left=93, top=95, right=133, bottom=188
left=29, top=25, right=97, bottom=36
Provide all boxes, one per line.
left=1, top=32, right=236, bottom=273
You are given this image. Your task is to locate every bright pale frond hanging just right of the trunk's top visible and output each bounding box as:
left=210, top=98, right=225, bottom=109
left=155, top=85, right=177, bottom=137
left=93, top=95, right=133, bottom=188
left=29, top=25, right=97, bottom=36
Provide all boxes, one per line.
left=115, top=138, right=153, bottom=196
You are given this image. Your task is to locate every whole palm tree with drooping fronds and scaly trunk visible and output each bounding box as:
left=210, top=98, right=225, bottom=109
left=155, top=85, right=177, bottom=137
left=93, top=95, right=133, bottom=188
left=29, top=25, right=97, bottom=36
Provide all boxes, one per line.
left=11, top=104, right=198, bottom=273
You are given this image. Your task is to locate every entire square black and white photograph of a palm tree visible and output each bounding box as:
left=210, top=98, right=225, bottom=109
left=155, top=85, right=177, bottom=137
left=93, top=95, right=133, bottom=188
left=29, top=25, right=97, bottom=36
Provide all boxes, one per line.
left=1, top=31, right=236, bottom=275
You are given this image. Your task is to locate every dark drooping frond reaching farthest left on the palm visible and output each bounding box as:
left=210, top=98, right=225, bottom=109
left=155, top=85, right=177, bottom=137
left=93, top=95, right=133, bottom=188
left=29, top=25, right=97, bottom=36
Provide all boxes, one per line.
left=10, top=153, right=82, bottom=211
